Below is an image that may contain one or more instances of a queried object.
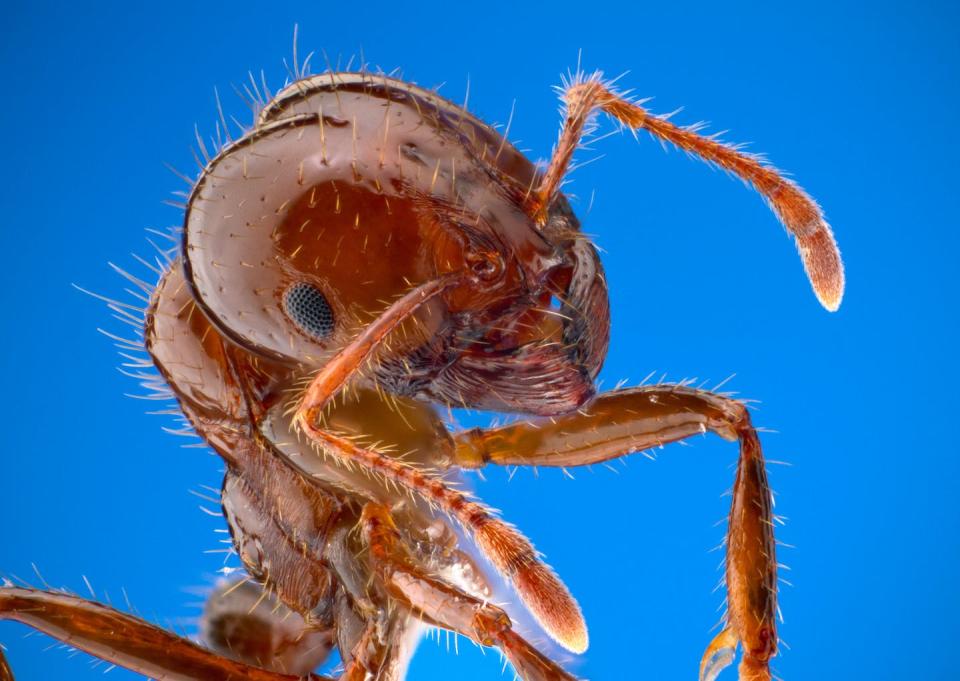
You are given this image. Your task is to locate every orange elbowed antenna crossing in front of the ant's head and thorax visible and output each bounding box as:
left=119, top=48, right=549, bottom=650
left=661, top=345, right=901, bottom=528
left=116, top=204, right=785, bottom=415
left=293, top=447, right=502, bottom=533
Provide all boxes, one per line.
left=293, top=275, right=588, bottom=653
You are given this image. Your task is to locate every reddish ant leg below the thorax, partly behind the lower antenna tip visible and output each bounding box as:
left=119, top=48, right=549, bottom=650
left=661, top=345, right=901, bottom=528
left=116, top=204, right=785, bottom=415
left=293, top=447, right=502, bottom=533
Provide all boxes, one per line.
left=361, top=503, right=575, bottom=681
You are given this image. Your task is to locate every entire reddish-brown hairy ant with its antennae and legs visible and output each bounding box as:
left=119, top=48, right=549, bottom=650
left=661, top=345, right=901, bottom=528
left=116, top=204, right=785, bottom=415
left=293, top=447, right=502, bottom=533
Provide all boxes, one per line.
left=0, top=65, right=843, bottom=680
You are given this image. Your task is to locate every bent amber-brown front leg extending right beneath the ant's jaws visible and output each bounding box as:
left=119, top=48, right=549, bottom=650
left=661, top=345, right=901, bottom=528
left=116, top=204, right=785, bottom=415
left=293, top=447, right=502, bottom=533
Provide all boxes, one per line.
left=455, top=385, right=777, bottom=681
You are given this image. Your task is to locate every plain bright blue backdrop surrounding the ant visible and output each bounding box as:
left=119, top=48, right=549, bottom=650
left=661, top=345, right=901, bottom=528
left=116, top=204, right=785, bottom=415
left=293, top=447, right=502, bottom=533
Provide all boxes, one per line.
left=0, top=1, right=960, bottom=681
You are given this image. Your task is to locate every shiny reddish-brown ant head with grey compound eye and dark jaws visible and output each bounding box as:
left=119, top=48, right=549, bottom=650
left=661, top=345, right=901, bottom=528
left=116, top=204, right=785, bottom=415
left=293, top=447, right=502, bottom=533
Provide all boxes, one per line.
left=184, top=74, right=608, bottom=413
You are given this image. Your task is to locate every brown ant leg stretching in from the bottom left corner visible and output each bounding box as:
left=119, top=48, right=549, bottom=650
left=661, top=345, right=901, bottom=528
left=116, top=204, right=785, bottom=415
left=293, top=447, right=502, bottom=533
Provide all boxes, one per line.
left=0, top=586, right=329, bottom=681
